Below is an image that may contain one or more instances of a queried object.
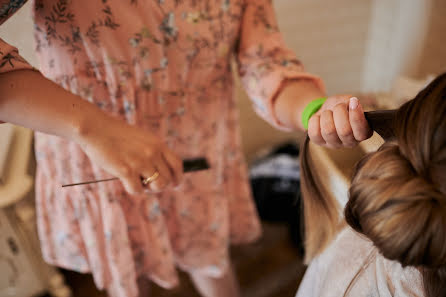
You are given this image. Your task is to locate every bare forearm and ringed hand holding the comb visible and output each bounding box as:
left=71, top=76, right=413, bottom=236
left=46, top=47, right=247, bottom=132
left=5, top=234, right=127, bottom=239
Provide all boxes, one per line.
left=0, top=70, right=183, bottom=193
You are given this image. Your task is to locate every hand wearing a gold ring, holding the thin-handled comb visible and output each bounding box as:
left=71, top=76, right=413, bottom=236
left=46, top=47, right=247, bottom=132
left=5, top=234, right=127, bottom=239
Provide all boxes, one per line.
left=74, top=114, right=183, bottom=194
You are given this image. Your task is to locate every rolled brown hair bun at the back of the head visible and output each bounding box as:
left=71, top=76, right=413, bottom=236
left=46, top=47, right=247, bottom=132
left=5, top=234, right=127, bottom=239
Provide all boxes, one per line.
left=345, top=144, right=446, bottom=267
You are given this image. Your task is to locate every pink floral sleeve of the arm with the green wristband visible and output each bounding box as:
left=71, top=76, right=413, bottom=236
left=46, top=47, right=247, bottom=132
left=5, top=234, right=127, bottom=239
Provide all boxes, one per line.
left=237, top=0, right=325, bottom=130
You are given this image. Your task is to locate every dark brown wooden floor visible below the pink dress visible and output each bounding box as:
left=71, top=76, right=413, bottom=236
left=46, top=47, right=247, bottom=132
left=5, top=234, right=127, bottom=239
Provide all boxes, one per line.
left=59, top=223, right=305, bottom=297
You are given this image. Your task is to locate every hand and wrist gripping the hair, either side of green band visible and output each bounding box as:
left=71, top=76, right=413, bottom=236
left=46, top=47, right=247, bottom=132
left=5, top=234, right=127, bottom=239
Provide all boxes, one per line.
left=274, top=80, right=373, bottom=148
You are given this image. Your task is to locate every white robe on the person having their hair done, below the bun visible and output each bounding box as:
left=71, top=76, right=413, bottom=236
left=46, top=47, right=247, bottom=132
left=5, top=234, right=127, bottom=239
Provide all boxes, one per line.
left=296, top=227, right=425, bottom=297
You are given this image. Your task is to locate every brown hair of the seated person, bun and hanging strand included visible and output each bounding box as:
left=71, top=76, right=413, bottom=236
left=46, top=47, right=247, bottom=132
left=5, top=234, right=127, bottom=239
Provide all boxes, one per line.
left=301, top=74, right=446, bottom=297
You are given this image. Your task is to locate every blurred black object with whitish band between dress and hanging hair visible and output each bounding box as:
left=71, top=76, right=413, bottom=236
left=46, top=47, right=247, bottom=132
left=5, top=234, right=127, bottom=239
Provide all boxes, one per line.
left=250, top=143, right=304, bottom=256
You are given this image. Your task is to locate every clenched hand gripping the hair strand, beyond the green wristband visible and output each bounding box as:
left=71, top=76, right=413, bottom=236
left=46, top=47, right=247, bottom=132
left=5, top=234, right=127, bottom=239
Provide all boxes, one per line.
left=308, top=95, right=373, bottom=148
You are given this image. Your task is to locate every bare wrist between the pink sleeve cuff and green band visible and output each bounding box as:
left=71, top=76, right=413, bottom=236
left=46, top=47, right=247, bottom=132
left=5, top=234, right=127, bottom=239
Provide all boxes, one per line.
left=274, top=79, right=325, bottom=130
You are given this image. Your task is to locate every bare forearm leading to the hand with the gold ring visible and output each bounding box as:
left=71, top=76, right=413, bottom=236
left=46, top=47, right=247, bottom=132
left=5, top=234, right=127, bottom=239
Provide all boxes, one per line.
left=0, top=70, right=106, bottom=140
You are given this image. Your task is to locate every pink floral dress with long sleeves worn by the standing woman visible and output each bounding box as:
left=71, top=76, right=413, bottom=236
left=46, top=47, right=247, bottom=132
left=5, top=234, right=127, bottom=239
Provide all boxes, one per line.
left=0, top=0, right=323, bottom=297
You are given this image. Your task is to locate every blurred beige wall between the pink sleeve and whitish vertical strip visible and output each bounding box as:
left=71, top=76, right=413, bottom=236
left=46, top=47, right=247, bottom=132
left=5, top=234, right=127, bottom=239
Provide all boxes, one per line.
left=274, top=0, right=372, bottom=93
